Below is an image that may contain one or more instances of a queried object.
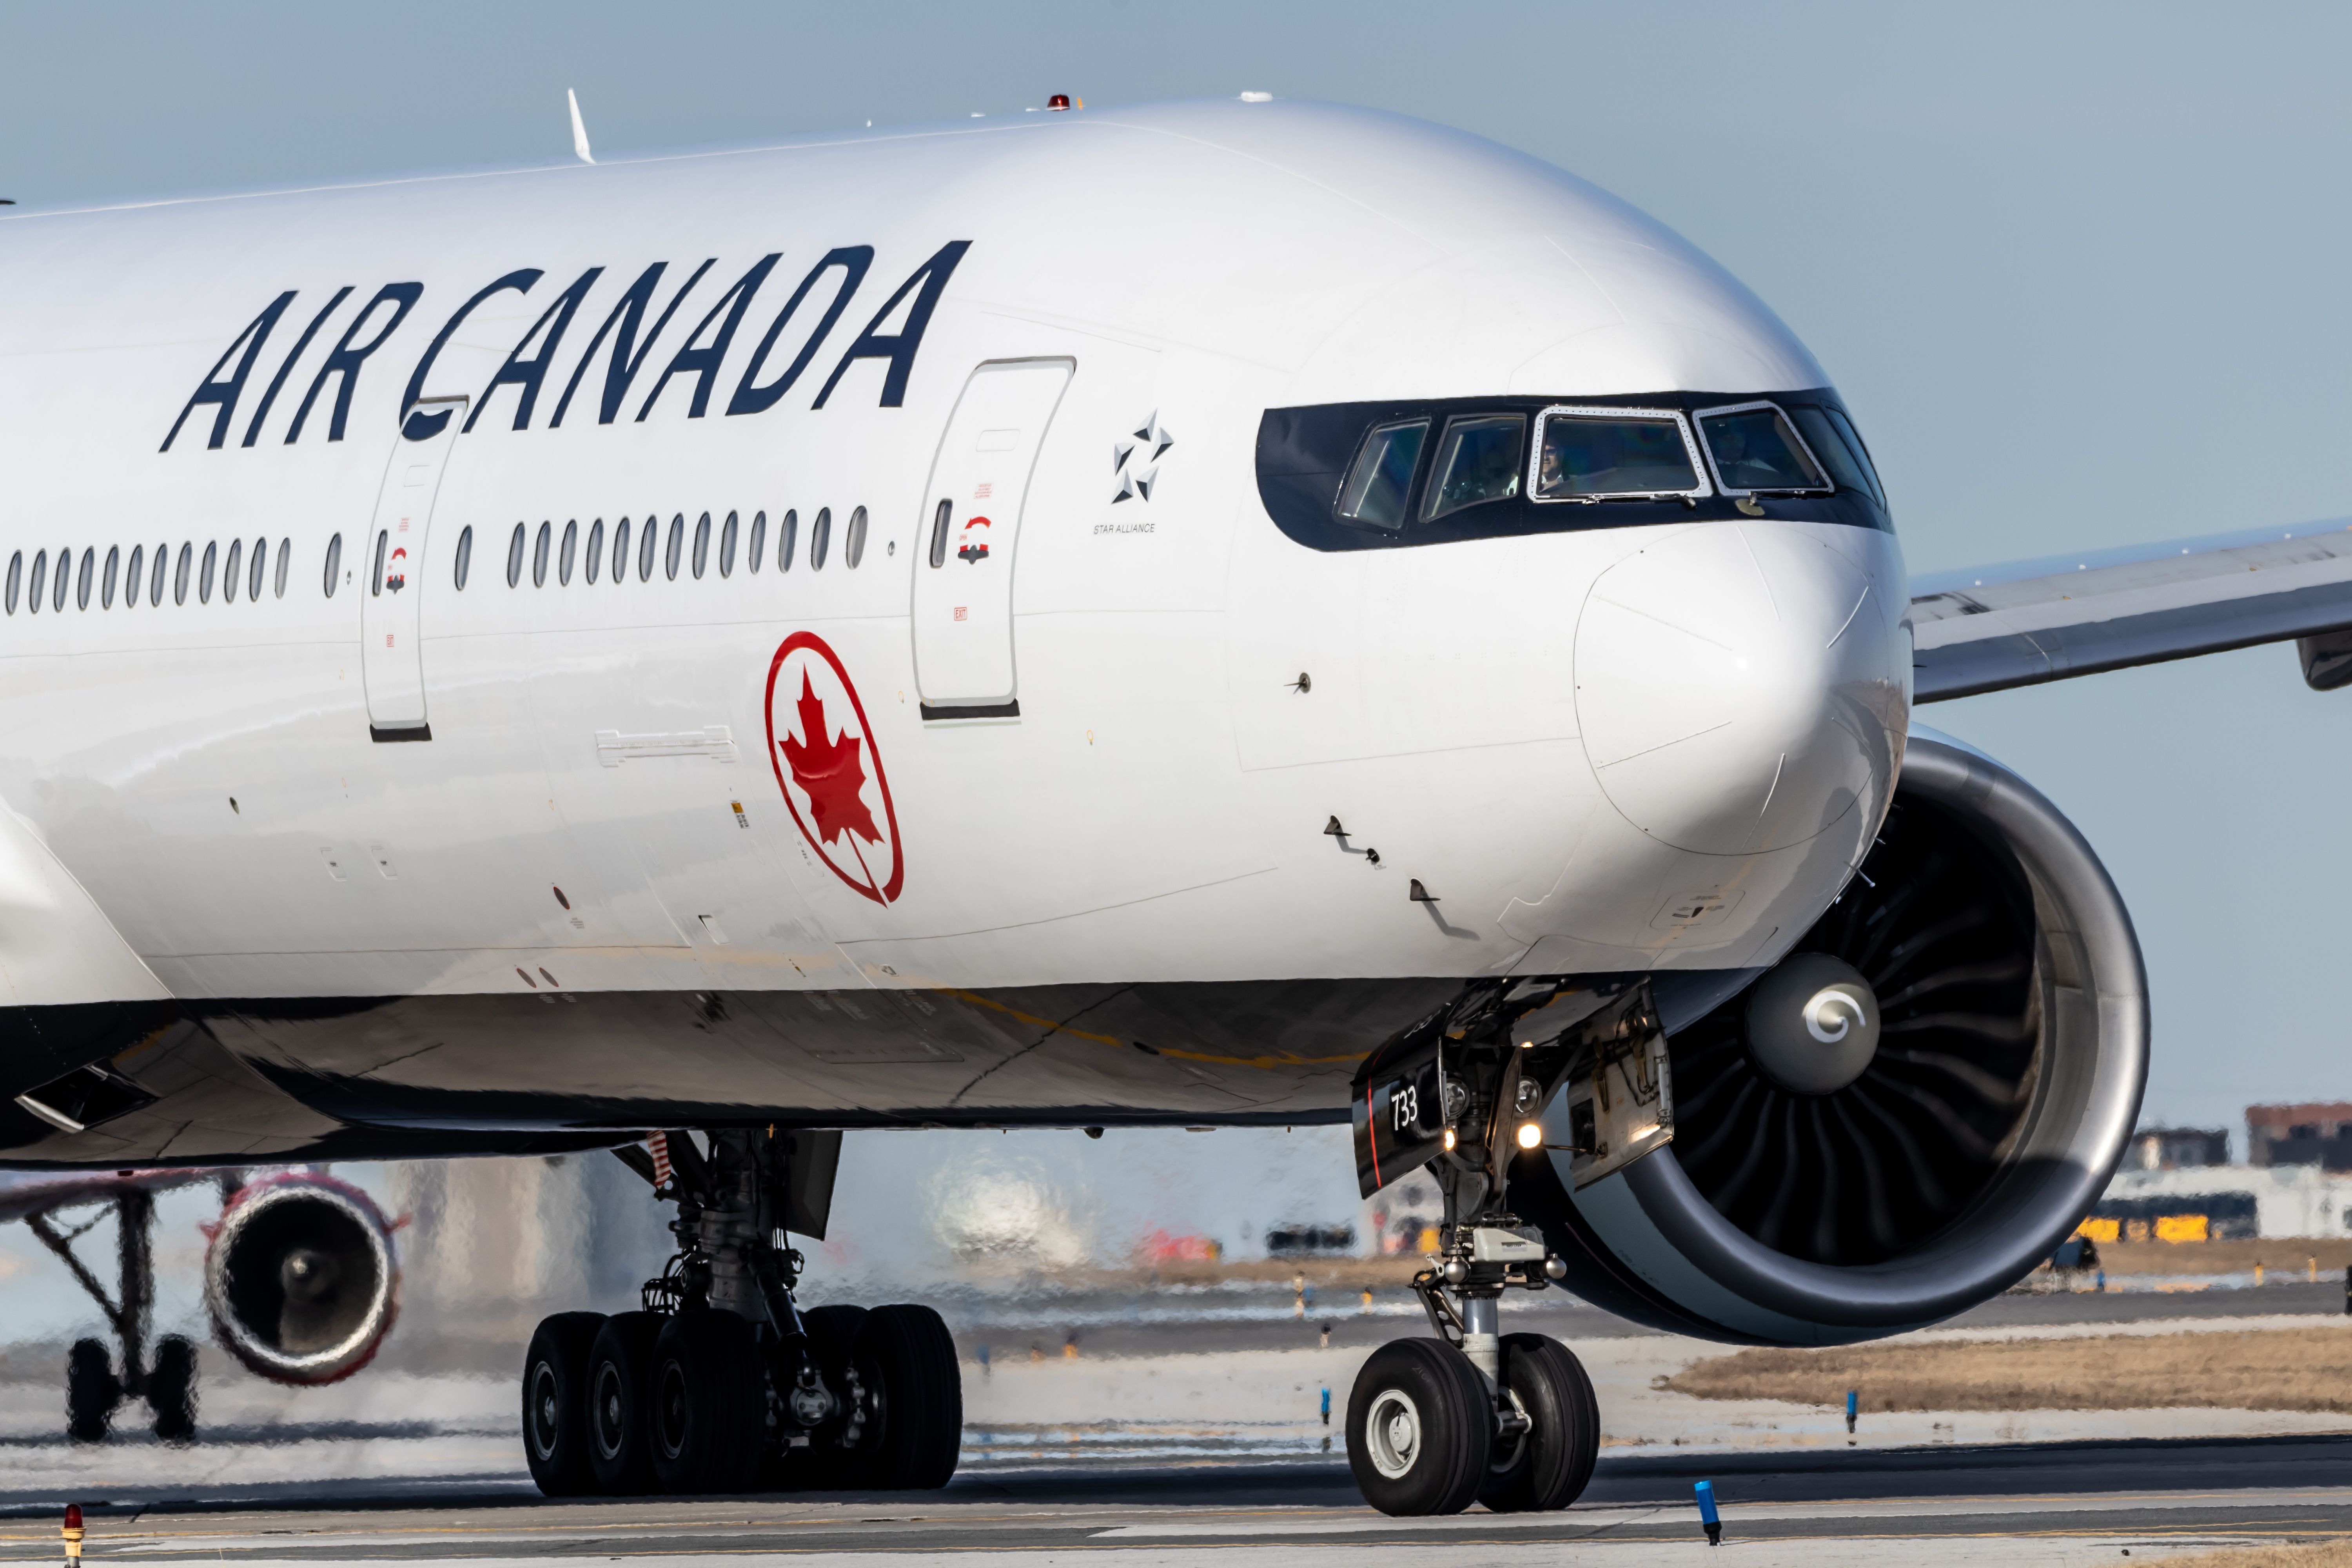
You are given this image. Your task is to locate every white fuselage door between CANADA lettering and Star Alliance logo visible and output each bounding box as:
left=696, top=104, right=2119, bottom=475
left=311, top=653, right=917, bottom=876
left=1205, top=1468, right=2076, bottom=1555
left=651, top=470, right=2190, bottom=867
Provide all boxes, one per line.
left=915, top=360, right=1077, bottom=719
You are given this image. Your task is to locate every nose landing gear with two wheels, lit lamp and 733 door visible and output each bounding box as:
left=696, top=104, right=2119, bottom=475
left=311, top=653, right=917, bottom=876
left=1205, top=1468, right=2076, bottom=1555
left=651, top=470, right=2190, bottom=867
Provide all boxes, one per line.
left=1348, top=980, right=1672, bottom=1514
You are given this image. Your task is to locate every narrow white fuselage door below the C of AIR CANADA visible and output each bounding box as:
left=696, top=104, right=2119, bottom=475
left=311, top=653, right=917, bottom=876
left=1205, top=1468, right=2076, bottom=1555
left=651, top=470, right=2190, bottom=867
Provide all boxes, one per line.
left=358, top=397, right=466, bottom=740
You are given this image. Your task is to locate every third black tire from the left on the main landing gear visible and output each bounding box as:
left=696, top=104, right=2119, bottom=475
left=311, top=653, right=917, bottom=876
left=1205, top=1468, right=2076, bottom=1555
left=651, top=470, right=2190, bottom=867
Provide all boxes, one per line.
left=647, top=1307, right=767, bottom=1495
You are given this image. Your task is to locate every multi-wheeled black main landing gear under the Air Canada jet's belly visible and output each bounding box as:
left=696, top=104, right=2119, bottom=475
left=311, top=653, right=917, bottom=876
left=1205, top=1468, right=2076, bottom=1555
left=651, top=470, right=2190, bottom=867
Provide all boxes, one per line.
left=522, top=1129, right=964, bottom=1497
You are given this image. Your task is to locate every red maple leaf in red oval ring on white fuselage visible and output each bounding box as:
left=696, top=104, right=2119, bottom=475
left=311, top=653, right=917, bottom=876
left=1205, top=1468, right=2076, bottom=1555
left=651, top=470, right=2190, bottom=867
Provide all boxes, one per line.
left=767, top=632, right=906, bottom=905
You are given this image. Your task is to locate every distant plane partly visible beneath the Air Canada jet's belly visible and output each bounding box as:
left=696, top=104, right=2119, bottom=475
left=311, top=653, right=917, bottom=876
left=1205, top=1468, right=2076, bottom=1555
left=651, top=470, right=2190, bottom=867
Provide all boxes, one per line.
left=0, top=1161, right=400, bottom=1443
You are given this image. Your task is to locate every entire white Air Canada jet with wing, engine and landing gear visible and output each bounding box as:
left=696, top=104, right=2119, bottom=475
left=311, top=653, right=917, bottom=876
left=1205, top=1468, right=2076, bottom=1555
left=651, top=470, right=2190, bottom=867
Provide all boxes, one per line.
left=0, top=94, right=2352, bottom=1514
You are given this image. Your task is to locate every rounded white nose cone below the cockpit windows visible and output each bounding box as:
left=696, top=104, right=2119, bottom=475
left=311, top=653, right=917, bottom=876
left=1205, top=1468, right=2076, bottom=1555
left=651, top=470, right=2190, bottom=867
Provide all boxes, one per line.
left=1576, top=522, right=1907, bottom=856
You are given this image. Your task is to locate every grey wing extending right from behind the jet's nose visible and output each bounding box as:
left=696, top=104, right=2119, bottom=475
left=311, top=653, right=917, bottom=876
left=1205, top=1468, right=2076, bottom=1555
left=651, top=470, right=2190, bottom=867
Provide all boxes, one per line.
left=1912, top=517, right=2352, bottom=703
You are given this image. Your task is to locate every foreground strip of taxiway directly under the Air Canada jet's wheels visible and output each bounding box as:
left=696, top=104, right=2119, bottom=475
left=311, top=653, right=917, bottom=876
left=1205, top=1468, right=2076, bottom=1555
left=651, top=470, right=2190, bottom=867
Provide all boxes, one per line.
left=0, top=1439, right=2352, bottom=1568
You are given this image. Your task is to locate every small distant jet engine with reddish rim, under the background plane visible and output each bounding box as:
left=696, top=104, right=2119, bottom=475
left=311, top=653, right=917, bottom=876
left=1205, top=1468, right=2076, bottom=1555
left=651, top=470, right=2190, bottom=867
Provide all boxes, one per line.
left=205, top=1173, right=400, bottom=1385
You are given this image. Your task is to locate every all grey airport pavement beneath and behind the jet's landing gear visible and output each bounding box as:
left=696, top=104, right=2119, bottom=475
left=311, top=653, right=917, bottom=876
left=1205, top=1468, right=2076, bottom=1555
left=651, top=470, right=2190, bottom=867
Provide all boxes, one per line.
left=0, top=1281, right=2352, bottom=1568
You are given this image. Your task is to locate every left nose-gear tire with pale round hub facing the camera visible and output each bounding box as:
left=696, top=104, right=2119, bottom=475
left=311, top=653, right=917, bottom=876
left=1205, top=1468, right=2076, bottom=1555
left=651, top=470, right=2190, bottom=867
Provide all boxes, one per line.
left=1348, top=1340, right=1494, bottom=1519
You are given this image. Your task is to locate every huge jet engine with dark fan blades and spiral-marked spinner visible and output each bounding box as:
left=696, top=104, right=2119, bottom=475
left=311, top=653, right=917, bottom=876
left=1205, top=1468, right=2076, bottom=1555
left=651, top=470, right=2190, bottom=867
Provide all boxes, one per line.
left=1510, top=729, right=2147, bottom=1345
